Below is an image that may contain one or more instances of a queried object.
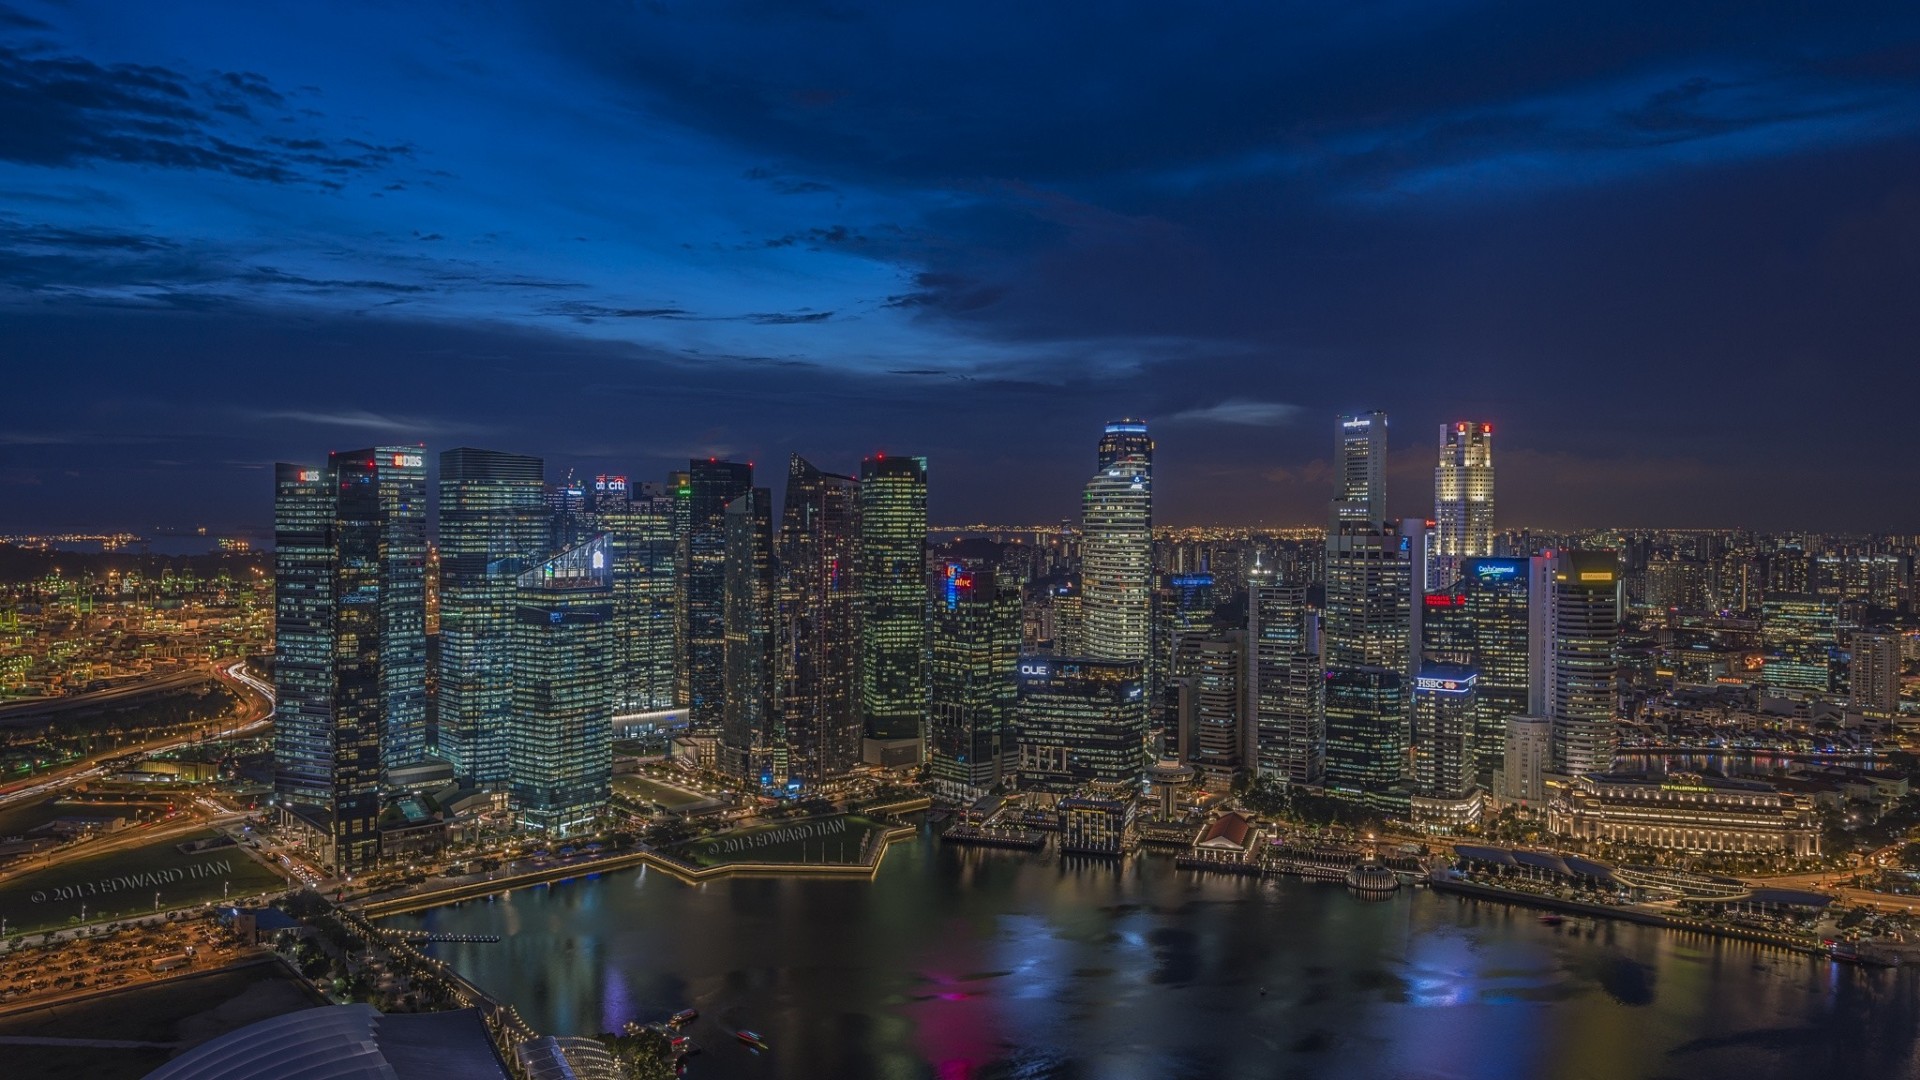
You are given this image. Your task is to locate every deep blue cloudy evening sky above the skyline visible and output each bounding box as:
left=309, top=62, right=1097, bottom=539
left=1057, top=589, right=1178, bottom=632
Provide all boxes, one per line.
left=0, top=0, right=1920, bottom=532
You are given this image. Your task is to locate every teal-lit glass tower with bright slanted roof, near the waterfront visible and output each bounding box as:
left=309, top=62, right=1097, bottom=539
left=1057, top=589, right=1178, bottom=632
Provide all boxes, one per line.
left=507, top=536, right=614, bottom=836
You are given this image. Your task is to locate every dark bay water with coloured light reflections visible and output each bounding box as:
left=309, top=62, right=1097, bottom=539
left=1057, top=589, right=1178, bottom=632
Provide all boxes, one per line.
left=390, top=818, right=1920, bottom=1080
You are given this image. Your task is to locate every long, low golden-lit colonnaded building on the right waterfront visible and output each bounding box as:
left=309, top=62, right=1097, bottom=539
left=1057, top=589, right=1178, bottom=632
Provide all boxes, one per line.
left=1548, top=773, right=1820, bottom=857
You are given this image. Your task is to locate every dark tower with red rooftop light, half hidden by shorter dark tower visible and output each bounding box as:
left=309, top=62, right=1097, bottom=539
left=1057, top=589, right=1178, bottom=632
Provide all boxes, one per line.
left=680, top=457, right=753, bottom=732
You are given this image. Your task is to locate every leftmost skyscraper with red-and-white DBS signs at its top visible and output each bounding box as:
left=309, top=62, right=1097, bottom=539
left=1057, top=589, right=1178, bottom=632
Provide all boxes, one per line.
left=275, top=446, right=428, bottom=872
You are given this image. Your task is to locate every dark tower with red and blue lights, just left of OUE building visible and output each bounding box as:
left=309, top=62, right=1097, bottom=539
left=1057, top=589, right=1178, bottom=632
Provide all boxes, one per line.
left=927, top=563, right=1020, bottom=799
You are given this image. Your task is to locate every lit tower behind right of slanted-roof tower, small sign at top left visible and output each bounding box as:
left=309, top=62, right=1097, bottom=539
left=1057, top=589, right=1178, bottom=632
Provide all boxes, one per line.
left=610, top=477, right=678, bottom=715
